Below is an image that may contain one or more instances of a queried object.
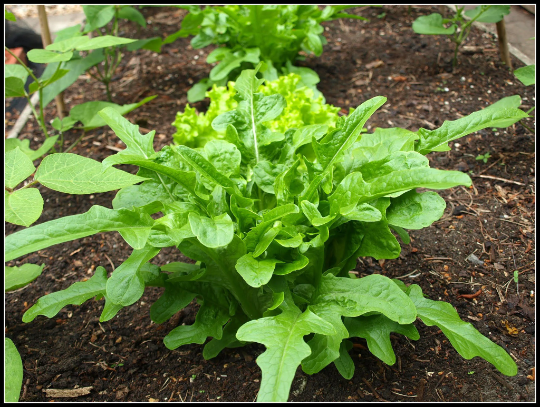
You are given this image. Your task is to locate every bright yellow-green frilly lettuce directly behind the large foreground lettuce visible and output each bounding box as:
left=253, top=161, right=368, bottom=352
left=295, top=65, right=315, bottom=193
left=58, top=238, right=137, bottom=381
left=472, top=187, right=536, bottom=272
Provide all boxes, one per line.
left=172, top=73, right=340, bottom=147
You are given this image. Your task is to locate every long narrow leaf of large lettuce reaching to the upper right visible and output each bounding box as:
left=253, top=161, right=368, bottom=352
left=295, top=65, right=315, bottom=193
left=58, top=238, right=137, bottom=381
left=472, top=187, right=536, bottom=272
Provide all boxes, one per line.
left=416, top=100, right=528, bottom=155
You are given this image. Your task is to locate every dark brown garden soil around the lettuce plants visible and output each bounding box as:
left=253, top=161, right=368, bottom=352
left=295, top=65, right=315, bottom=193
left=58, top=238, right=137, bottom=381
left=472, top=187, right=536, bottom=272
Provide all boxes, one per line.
left=5, top=6, right=535, bottom=402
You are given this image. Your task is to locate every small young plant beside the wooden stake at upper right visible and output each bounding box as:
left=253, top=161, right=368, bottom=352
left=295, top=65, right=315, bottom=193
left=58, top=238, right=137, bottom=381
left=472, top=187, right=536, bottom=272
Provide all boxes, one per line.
left=412, top=5, right=510, bottom=67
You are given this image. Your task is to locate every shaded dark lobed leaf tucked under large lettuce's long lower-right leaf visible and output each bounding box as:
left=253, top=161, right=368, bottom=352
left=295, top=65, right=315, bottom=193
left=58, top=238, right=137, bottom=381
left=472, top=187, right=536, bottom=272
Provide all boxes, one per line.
left=344, top=315, right=420, bottom=365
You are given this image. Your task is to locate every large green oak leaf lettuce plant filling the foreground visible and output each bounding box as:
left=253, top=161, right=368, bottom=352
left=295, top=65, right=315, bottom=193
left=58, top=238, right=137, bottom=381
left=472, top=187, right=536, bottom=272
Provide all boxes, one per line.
left=5, top=70, right=526, bottom=401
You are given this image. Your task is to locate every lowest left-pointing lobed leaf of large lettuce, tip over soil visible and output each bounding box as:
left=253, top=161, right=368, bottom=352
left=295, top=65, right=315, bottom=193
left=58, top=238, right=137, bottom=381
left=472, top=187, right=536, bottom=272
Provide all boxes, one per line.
left=22, top=266, right=107, bottom=323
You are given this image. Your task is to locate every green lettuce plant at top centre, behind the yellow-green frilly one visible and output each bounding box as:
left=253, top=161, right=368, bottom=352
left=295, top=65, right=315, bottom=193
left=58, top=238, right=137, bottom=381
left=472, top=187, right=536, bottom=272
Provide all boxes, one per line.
left=164, top=5, right=366, bottom=103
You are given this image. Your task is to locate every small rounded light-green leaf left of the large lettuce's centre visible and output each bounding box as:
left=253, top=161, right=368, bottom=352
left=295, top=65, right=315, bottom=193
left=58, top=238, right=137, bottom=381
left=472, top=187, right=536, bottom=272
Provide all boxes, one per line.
left=189, top=212, right=234, bottom=248
